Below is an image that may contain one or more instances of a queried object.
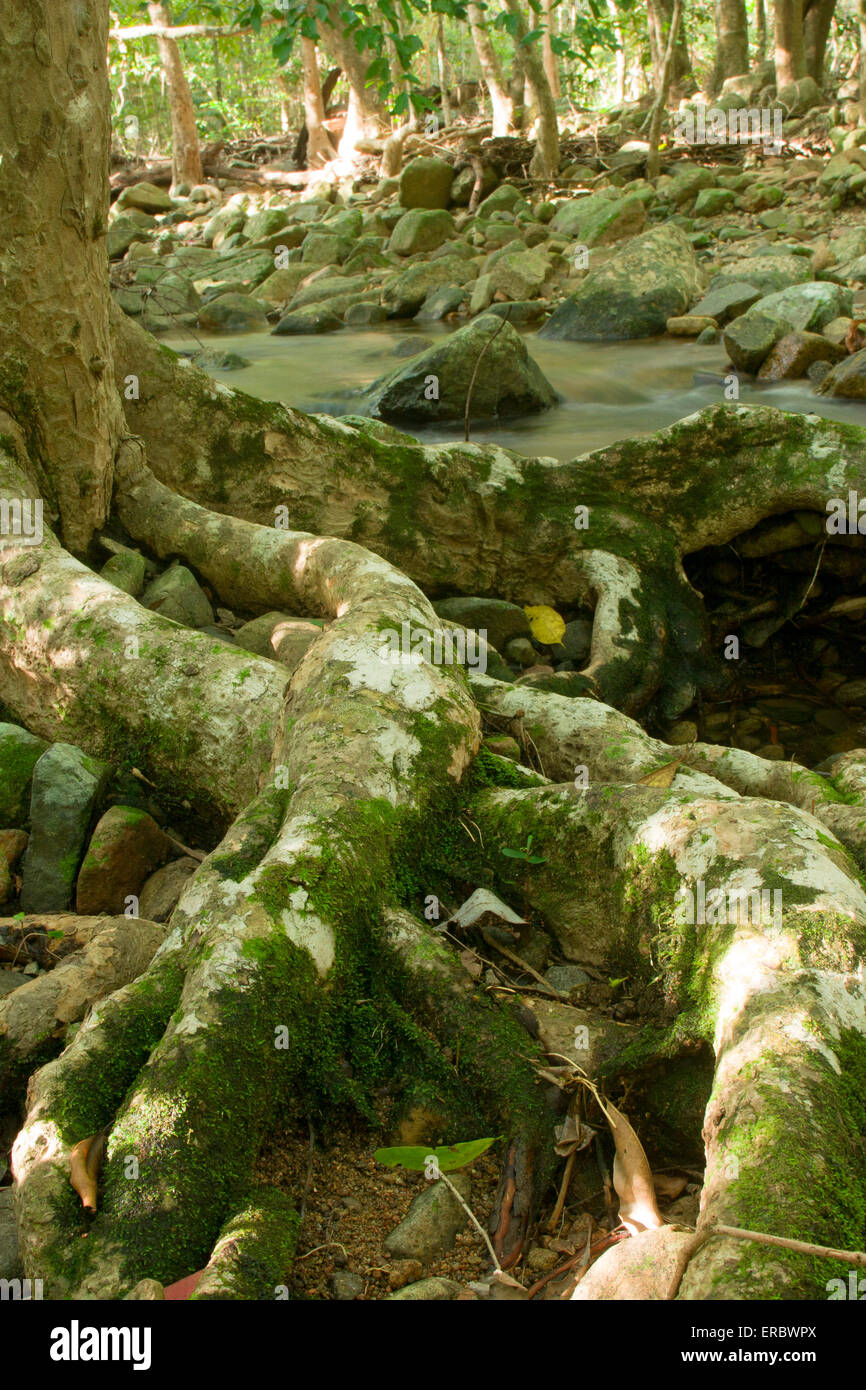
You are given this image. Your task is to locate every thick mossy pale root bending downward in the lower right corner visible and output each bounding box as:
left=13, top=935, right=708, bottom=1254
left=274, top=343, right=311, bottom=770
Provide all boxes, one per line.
left=468, top=784, right=866, bottom=1300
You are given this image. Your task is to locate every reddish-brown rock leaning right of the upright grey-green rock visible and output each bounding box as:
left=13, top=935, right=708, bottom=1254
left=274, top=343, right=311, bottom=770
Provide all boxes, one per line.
left=75, top=806, right=174, bottom=916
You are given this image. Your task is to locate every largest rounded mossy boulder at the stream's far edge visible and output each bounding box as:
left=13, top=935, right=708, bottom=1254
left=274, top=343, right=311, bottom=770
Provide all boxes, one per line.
left=538, top=224, right=699, bottom=342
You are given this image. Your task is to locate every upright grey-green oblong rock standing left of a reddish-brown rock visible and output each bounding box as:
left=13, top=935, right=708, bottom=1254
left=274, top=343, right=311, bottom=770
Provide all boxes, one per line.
left=21, top=744, right=110, bottom=912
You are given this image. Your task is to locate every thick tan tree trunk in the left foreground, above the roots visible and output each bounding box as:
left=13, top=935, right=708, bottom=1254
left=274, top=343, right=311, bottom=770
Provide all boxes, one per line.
left=0, top=0, right=125, bottom=553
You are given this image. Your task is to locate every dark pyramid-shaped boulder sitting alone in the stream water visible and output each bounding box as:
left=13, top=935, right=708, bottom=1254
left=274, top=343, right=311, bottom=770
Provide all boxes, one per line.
left=367, top=314, right=556, bottom=424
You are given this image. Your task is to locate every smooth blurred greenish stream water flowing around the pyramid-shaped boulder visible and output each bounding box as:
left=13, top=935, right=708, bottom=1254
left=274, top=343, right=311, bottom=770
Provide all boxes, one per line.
left=167, top=324, right=866, bottom=459
